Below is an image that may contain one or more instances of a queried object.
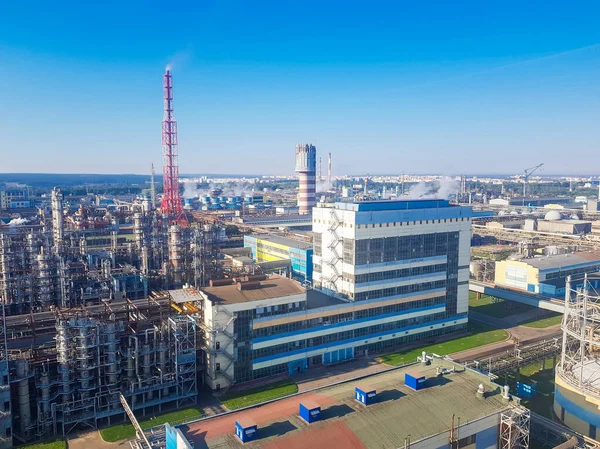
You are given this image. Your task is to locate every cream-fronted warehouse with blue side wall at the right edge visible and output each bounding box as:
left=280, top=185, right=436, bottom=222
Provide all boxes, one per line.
left=494, top=251, right=600, bottom=297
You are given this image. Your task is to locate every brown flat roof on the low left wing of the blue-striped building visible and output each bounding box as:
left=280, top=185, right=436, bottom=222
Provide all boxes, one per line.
left=200, top=275, right=306, bottom=304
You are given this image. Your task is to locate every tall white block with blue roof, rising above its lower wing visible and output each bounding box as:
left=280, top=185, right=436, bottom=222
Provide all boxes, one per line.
left=313, top=200, right=473, bottom=317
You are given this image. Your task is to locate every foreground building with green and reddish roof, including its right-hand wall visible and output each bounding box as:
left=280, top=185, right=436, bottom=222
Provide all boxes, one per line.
left=184, top=358, right=530, bottom=449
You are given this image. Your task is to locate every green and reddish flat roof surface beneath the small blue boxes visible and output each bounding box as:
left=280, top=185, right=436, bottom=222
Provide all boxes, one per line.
left=181, top=360, right=508, bottom=449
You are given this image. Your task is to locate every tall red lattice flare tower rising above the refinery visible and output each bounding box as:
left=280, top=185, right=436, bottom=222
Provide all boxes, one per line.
left=160, top=69, right=187, bottom=225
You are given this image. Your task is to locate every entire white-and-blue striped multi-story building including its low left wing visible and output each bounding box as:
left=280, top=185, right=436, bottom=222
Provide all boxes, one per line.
left=200, top=200, right=472, bottom=388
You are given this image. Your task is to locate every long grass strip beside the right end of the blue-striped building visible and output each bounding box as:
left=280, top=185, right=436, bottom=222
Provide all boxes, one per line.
left=380, top=322, right=508, bottom=366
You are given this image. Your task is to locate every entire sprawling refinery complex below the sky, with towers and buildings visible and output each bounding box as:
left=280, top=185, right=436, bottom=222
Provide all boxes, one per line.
left=0, top=66, right=600, bottom=449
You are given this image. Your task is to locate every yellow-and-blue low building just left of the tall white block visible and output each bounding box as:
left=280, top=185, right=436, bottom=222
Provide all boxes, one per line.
left=244, top=234, right=313, bottom=282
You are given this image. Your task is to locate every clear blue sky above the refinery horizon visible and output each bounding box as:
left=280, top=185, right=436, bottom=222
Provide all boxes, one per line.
left=0, top=0, right=600, bottom=174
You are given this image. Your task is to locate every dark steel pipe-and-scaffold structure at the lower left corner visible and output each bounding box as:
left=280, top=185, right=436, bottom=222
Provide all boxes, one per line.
left=4, top=294, right=199, bottom=442
